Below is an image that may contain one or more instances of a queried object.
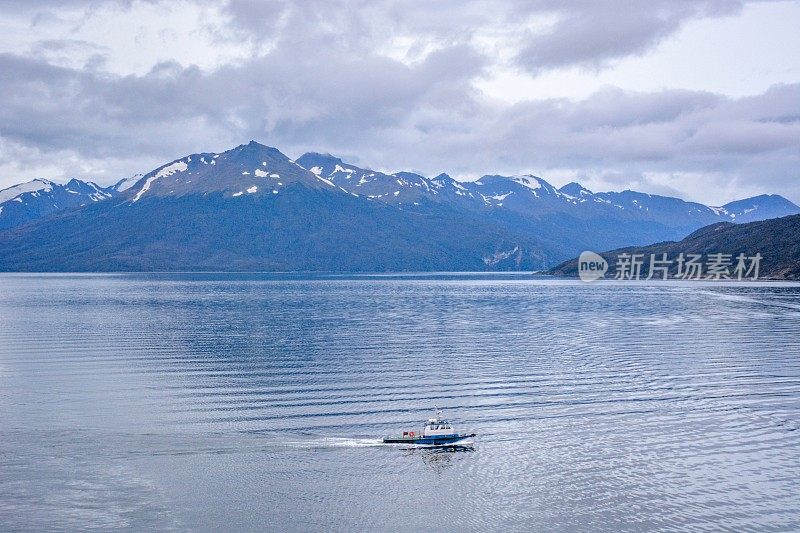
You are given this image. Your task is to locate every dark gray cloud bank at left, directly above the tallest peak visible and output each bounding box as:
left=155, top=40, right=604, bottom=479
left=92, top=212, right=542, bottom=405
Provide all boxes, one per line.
left=0, top=36, right=483, bottom=169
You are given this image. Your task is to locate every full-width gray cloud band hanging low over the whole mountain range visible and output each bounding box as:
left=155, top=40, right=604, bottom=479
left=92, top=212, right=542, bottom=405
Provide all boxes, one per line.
left=0, top=45, right=800, bottom=199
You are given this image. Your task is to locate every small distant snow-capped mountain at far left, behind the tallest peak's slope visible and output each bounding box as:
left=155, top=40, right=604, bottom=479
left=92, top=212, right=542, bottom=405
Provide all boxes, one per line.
left=0, top=179, right=114, bottom=229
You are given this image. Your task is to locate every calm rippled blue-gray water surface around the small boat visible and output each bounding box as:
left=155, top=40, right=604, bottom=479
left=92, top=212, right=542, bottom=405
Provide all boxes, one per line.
left=0, top=274, right=800, bottom=531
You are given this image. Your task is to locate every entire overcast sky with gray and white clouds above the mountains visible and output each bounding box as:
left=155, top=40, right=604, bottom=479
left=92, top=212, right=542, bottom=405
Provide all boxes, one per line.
left=0, top=0, right=800, bottom=204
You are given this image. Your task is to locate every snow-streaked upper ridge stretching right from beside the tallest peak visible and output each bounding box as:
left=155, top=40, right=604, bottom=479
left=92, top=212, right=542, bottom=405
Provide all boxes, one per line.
left=297, top=152, right=800, bottom=232
